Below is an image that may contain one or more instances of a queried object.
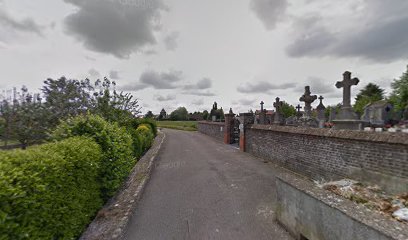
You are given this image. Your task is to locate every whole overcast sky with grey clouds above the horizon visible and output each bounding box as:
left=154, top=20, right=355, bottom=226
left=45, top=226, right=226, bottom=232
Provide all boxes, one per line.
left=0, top=0, right=408, bottom=113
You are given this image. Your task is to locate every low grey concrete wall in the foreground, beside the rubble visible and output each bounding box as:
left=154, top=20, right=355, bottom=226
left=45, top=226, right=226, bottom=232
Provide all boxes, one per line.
left=276, top=174, right=408, bottom=240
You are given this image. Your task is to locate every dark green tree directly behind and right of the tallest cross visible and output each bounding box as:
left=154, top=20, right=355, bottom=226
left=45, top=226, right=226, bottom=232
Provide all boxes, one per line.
left=353, top=83, right=384, bottom=115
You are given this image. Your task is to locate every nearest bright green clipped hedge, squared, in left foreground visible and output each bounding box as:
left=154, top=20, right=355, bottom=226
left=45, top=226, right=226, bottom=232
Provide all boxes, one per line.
left=0, top=137, right=102, bottom=239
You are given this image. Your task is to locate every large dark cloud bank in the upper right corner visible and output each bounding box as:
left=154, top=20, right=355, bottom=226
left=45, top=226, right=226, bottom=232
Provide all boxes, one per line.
left=286, top=0, right=408, bottom=62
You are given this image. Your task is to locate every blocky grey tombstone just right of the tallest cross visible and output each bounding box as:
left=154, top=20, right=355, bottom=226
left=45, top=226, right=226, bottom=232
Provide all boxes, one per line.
left=361, top=100, right=393, bottom=127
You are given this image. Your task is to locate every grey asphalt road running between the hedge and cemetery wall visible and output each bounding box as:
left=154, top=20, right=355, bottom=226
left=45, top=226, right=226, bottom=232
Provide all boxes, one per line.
left=125, top=129, right=292, bottom=240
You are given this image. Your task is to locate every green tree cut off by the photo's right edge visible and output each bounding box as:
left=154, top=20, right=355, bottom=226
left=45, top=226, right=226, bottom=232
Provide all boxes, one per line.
left=390, top=66, right=408, bottom=112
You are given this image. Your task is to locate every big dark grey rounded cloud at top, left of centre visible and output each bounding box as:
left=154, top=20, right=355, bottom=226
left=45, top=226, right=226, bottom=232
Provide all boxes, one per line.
left=64, top=0, right=166, bottom=58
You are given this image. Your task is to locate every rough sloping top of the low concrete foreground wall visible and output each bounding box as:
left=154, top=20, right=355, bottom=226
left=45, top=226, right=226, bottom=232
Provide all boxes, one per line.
left=276, top=172, right=408, bottom=240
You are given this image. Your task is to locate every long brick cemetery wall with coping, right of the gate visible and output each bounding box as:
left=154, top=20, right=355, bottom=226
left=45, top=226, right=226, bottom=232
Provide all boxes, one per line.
left=245, top=125, right=408, bottom=193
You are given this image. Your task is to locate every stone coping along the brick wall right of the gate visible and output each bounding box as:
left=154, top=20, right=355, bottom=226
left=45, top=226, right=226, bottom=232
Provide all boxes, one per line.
left=249, top=125, right=408, bottom=145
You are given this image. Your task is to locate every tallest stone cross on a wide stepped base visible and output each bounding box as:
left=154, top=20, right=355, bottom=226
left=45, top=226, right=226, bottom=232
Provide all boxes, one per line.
left=333, top=71, right=363, bottom=130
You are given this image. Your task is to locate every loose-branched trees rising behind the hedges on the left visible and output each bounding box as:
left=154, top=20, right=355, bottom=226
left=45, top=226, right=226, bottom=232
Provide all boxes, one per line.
left=0, top=77, right=141, bottom=148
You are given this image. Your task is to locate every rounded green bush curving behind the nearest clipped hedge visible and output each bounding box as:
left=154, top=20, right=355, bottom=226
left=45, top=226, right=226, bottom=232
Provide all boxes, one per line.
left=52, top=115, right=136, bottom=200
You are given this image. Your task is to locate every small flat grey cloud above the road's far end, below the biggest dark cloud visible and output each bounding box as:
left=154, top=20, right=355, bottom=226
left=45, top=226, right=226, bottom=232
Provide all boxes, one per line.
left=140, top=70, right=182, bottom=89
